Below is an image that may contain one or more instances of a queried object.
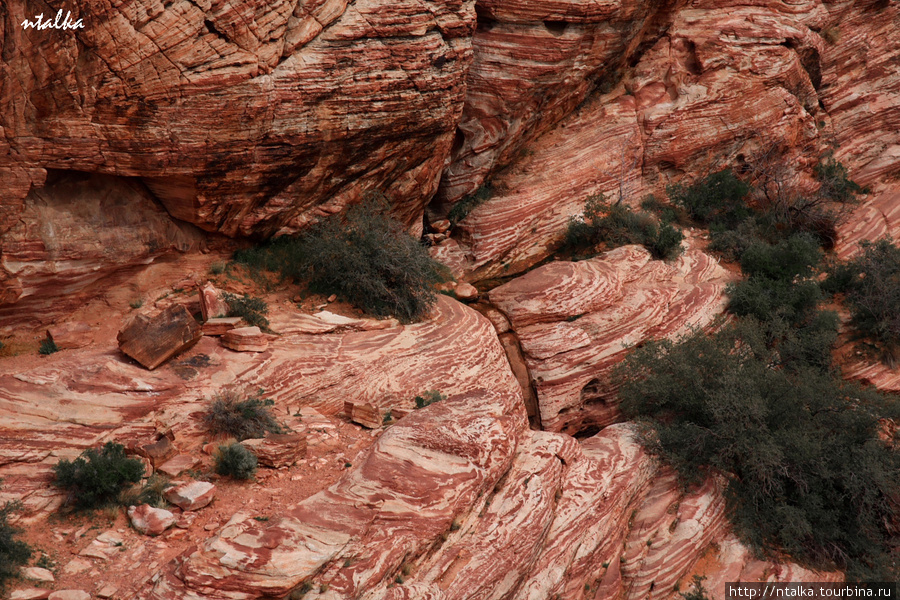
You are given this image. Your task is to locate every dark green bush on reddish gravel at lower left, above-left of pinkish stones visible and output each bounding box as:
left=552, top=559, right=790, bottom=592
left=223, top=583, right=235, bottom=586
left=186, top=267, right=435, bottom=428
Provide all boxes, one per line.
left=53, top=442, right=144, bottom=510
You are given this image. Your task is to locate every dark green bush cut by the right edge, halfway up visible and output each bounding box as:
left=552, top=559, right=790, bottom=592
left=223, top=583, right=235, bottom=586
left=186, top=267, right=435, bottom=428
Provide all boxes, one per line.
left=824, top=239, right=900, bottom=362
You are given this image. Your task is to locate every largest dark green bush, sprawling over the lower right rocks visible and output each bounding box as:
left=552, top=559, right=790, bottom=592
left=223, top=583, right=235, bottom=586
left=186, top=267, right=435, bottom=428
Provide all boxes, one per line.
left=617, top=320, right=900, bottom=580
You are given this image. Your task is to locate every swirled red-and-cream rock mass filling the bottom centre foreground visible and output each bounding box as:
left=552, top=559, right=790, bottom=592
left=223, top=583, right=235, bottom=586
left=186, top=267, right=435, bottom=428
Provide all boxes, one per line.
left=142, top=426, right=840, bottom=600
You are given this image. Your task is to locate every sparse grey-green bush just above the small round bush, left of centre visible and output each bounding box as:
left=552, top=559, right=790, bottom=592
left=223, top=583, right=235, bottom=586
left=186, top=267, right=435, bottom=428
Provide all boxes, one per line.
left=203, top=389, right=284, bottom=441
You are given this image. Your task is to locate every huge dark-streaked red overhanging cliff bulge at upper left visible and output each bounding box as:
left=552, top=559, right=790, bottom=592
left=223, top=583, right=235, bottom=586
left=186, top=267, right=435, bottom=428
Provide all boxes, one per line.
left=0, top=0, right=474, bottom=235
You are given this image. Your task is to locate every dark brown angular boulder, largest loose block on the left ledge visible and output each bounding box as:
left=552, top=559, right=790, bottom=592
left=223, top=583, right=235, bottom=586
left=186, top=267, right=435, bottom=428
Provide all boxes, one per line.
left=116, top=304, right=203, bottom=370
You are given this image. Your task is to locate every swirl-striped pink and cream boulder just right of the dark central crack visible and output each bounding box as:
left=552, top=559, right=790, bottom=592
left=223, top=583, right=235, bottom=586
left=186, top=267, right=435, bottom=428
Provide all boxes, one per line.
left=490, top=241, right=734, bottom=433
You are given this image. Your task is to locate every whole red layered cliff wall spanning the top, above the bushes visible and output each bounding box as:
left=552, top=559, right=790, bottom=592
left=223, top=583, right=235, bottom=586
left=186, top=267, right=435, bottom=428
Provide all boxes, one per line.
left=0, top=0, right=900, bottom=312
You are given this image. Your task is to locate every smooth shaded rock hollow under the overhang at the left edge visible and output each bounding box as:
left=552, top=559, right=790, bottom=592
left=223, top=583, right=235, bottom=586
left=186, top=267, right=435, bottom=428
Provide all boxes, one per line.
left=0, top=171, right=201, bottom=327
